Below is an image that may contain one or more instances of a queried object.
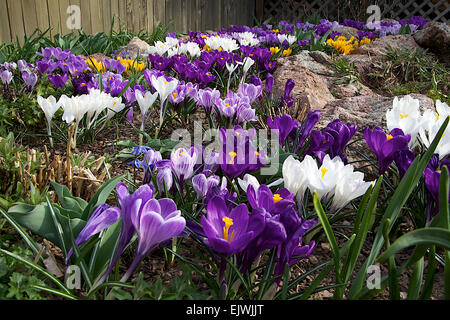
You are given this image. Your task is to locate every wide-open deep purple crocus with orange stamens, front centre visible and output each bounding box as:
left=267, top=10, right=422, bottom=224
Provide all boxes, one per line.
left=201, top=196, right=254, bottom=257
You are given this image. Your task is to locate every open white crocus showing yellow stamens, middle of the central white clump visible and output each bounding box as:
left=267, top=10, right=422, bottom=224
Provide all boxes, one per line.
left=304, top=155, right=344, bottom=200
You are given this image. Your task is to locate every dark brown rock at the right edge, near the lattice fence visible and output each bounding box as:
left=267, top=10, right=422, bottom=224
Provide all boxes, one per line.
left=413, top=21, right=450, bottom=55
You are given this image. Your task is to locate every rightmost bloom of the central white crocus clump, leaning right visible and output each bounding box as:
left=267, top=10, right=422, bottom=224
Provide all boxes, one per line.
left=331, top=165, right=375, bottom=210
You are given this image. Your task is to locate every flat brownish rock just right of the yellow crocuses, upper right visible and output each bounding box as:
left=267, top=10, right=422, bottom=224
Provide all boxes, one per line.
left=350, top=34, right=420, bottom=56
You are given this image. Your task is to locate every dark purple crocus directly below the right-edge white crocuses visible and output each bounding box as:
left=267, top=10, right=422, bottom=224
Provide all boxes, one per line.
left=364, top=127, right=411, bottom=174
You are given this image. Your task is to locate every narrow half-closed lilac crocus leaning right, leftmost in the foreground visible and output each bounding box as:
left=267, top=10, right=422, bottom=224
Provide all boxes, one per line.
left=66, top=203, right=120, bottom=263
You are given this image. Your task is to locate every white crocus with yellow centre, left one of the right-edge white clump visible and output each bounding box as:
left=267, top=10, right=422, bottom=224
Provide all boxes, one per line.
left=386, top=95, right=422, bottom=148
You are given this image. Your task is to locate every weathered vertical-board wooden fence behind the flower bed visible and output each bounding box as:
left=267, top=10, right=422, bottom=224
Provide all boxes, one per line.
left=0, top=0, right=262, bottom=43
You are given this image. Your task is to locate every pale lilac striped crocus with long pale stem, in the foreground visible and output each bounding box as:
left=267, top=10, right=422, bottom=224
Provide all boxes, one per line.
left=121, top=199, right=186, bottom=282
